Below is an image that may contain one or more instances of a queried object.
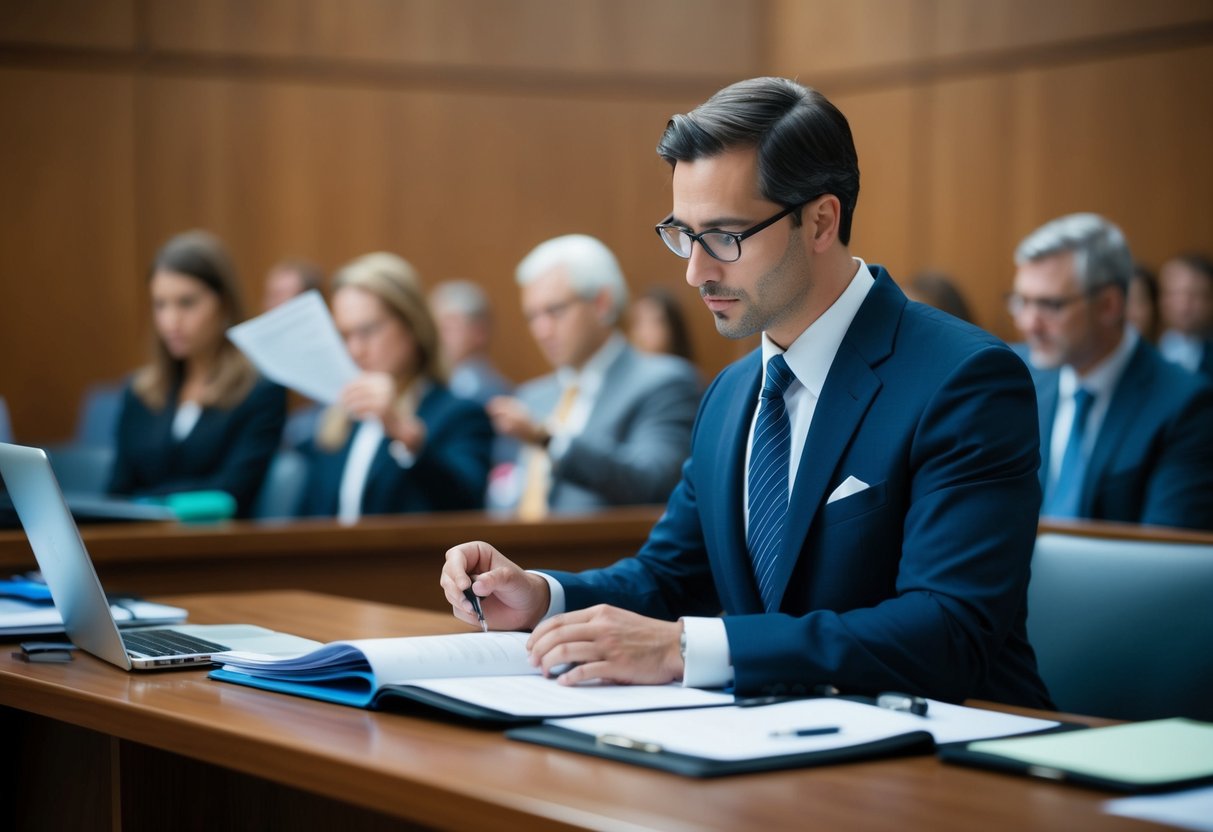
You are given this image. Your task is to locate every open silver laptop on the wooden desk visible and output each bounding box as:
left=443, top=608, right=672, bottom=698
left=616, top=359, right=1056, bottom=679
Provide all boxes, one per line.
left=0, top=443, right=320, bottom=671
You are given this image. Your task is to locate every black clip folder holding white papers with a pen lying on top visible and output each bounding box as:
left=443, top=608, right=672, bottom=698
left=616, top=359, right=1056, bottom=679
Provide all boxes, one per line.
left=506, top=697, right=1058, bottom=777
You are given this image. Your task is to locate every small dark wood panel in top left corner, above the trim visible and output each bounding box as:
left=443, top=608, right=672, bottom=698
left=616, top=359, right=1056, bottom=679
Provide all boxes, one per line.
left=0, top=0, right=136, bottom=49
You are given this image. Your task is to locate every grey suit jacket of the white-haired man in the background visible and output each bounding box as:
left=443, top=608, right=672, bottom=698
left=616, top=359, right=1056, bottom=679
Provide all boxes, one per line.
left=517, top=347, right=702, bottom=512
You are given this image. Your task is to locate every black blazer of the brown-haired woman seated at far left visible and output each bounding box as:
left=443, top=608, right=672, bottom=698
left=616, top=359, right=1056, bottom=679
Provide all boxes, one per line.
left=109, top=378, right=286, bottom=517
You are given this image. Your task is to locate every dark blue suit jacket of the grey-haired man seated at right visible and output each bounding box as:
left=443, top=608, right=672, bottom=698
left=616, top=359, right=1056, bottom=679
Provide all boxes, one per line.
left=1032, top=340, right=1213, bottom=529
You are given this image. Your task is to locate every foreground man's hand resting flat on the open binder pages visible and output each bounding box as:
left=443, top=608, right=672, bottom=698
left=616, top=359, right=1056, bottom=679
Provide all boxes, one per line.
left=526, top=604, right=683, bottom=685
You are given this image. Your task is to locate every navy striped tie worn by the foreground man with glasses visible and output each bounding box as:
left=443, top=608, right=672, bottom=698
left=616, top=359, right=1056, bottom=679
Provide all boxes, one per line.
left=746, top=355, right=796, bottom=611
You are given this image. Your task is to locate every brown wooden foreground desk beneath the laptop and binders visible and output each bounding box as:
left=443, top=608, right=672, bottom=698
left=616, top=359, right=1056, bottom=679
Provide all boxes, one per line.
left=0, top=592, right=1164, bottom=832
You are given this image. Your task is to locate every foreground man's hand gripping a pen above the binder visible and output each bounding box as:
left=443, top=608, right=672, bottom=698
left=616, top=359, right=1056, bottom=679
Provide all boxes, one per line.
left=439, top=541, right=552, bottom=629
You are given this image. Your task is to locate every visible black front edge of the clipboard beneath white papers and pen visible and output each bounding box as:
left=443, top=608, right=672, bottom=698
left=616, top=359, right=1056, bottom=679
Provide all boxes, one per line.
left=506, top=725, right=935, bottom=777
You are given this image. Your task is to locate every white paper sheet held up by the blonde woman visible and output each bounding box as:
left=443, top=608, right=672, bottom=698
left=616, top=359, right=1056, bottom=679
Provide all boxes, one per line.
left=227, top=290, right=360, bottom=404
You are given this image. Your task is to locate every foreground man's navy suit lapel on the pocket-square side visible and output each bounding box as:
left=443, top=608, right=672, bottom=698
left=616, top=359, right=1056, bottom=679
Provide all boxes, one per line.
left=756, top=271, right=906, bottom=606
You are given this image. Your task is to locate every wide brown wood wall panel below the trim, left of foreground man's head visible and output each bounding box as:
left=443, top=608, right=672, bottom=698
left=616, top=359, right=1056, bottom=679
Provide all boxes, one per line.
left=138, top=79, right=733, bottom=395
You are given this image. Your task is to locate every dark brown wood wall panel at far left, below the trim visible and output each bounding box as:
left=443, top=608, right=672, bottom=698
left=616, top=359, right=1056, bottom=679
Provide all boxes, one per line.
left=0, top=70, right=142, bottom=439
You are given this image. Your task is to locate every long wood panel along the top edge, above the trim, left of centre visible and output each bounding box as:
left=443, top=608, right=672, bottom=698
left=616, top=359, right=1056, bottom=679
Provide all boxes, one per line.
left=148, top=0, right=763, bottom=76
